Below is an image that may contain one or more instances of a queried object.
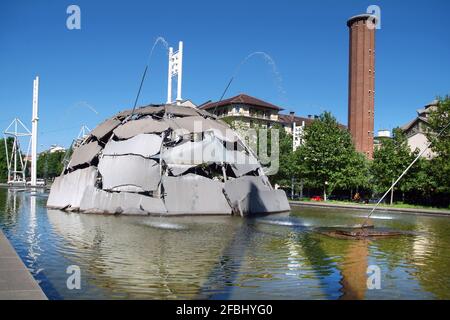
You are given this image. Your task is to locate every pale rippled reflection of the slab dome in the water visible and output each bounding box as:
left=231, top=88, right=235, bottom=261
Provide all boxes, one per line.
left=48, top=210, right=241, bottom=298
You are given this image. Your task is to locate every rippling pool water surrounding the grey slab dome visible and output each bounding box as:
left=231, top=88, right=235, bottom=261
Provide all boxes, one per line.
left=0, top=188, right=450, bottom=299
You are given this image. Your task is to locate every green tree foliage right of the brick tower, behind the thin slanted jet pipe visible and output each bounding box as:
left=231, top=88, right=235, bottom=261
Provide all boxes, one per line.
left=371, top=97, right=450, bottom=206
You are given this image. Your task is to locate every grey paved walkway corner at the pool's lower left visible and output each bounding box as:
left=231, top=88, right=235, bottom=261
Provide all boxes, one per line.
left=0, top=230, right=47, bottom=300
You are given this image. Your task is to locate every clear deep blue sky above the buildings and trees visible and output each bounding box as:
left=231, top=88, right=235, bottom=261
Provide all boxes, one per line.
left=0, top=0, right=450, bottom=150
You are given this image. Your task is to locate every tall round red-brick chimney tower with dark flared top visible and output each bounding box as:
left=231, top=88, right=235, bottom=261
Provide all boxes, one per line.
left=347, top=14, right=376, bottom=159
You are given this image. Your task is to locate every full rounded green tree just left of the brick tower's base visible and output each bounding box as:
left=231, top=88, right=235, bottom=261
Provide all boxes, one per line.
left=295, top=112, right=368, bottom=199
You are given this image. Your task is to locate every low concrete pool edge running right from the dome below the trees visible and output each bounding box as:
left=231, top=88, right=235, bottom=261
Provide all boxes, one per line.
left=289, top=201, right=450, bottom=217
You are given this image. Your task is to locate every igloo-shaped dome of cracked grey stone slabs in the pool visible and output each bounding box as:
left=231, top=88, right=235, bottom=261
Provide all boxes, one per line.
left=47, top=105, right=290, bottom=216
